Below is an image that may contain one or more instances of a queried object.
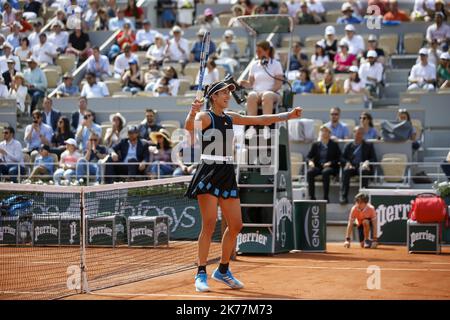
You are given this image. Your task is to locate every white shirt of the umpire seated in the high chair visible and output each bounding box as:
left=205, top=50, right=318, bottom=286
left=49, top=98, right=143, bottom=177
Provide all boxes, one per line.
left=249, top=59, right=283, bottom=92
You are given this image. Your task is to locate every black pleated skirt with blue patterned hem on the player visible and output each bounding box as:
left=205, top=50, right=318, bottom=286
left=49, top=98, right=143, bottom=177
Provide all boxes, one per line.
left=185, top=162, right=239, bottom=199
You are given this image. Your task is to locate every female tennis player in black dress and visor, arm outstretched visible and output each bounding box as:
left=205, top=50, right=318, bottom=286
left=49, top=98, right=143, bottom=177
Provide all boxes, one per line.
left=185, top=81, right=302, bottom=292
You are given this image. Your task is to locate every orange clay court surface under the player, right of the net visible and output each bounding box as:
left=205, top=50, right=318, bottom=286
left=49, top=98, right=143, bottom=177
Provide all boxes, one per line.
left=66, top=243, right=450, bottom=300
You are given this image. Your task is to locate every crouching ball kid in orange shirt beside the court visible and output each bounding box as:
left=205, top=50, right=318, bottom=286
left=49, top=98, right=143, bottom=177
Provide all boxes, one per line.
left=344, top=193, right=378, bottom=248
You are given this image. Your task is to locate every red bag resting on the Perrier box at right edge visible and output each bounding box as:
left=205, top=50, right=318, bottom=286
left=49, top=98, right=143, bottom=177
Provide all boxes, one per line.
left=408, top=193, right=449, bottom=226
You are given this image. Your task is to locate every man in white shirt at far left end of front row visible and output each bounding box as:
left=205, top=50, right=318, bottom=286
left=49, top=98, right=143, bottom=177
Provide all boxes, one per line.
left=0, top=126, right=25, bottom=182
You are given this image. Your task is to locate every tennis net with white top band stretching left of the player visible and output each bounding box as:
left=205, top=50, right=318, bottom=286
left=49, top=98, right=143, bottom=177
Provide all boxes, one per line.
left=0, top=177, right=222, bottom=299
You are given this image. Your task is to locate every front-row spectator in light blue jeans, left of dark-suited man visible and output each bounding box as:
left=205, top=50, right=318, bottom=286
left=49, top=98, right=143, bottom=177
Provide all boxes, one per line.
left=76, top=133, right=108, bottom=183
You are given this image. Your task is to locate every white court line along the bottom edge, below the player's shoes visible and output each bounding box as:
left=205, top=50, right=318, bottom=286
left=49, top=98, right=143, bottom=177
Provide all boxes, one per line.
left=88, top=292, right=299, bottom=300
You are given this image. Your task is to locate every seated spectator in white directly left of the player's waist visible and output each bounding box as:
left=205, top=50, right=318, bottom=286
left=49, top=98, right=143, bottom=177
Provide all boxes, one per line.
left=173, top=134, right=201, bottom=176
